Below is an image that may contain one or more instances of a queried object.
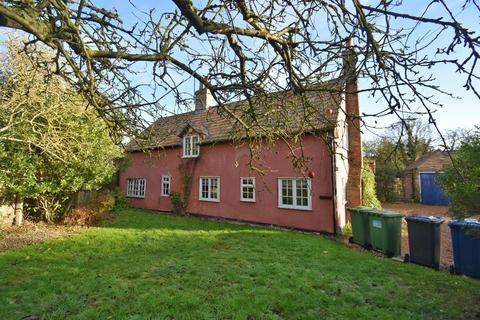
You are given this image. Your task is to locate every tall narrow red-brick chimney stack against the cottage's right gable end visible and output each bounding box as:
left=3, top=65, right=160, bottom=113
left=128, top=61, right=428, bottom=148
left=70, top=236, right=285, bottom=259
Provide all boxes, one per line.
left=343, top=38, right=362, bottom=207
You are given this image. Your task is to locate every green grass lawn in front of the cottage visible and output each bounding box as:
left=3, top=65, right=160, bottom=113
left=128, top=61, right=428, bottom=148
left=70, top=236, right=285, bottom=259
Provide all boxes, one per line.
left=0, top=209, right=480, bottom=319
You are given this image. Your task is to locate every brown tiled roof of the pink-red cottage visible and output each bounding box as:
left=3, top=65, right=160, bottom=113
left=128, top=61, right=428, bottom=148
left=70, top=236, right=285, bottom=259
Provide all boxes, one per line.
left=127, top=83, right=342, bottom=151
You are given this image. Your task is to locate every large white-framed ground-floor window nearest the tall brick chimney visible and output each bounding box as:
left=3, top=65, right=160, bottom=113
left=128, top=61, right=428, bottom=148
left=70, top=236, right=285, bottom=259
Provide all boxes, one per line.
left=278, top=178, right=312, bottom=210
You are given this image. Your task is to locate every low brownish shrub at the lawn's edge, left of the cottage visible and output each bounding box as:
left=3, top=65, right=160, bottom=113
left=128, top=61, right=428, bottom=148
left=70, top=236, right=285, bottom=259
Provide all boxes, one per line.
left=62, top=190, right=115, bottom=226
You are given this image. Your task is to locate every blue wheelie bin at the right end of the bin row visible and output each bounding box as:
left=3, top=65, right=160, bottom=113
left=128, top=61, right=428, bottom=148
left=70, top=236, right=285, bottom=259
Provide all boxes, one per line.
left=448, top=219, right=480, bottom=278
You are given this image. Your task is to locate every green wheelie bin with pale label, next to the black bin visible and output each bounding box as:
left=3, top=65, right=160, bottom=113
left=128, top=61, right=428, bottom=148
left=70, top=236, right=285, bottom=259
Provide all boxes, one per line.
left=369, top=209, right=403, bottom=257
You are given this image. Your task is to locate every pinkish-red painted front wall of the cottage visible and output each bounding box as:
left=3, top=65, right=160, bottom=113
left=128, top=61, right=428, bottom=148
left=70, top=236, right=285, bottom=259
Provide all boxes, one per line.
left=120, top=135, right=334, bottom=232
